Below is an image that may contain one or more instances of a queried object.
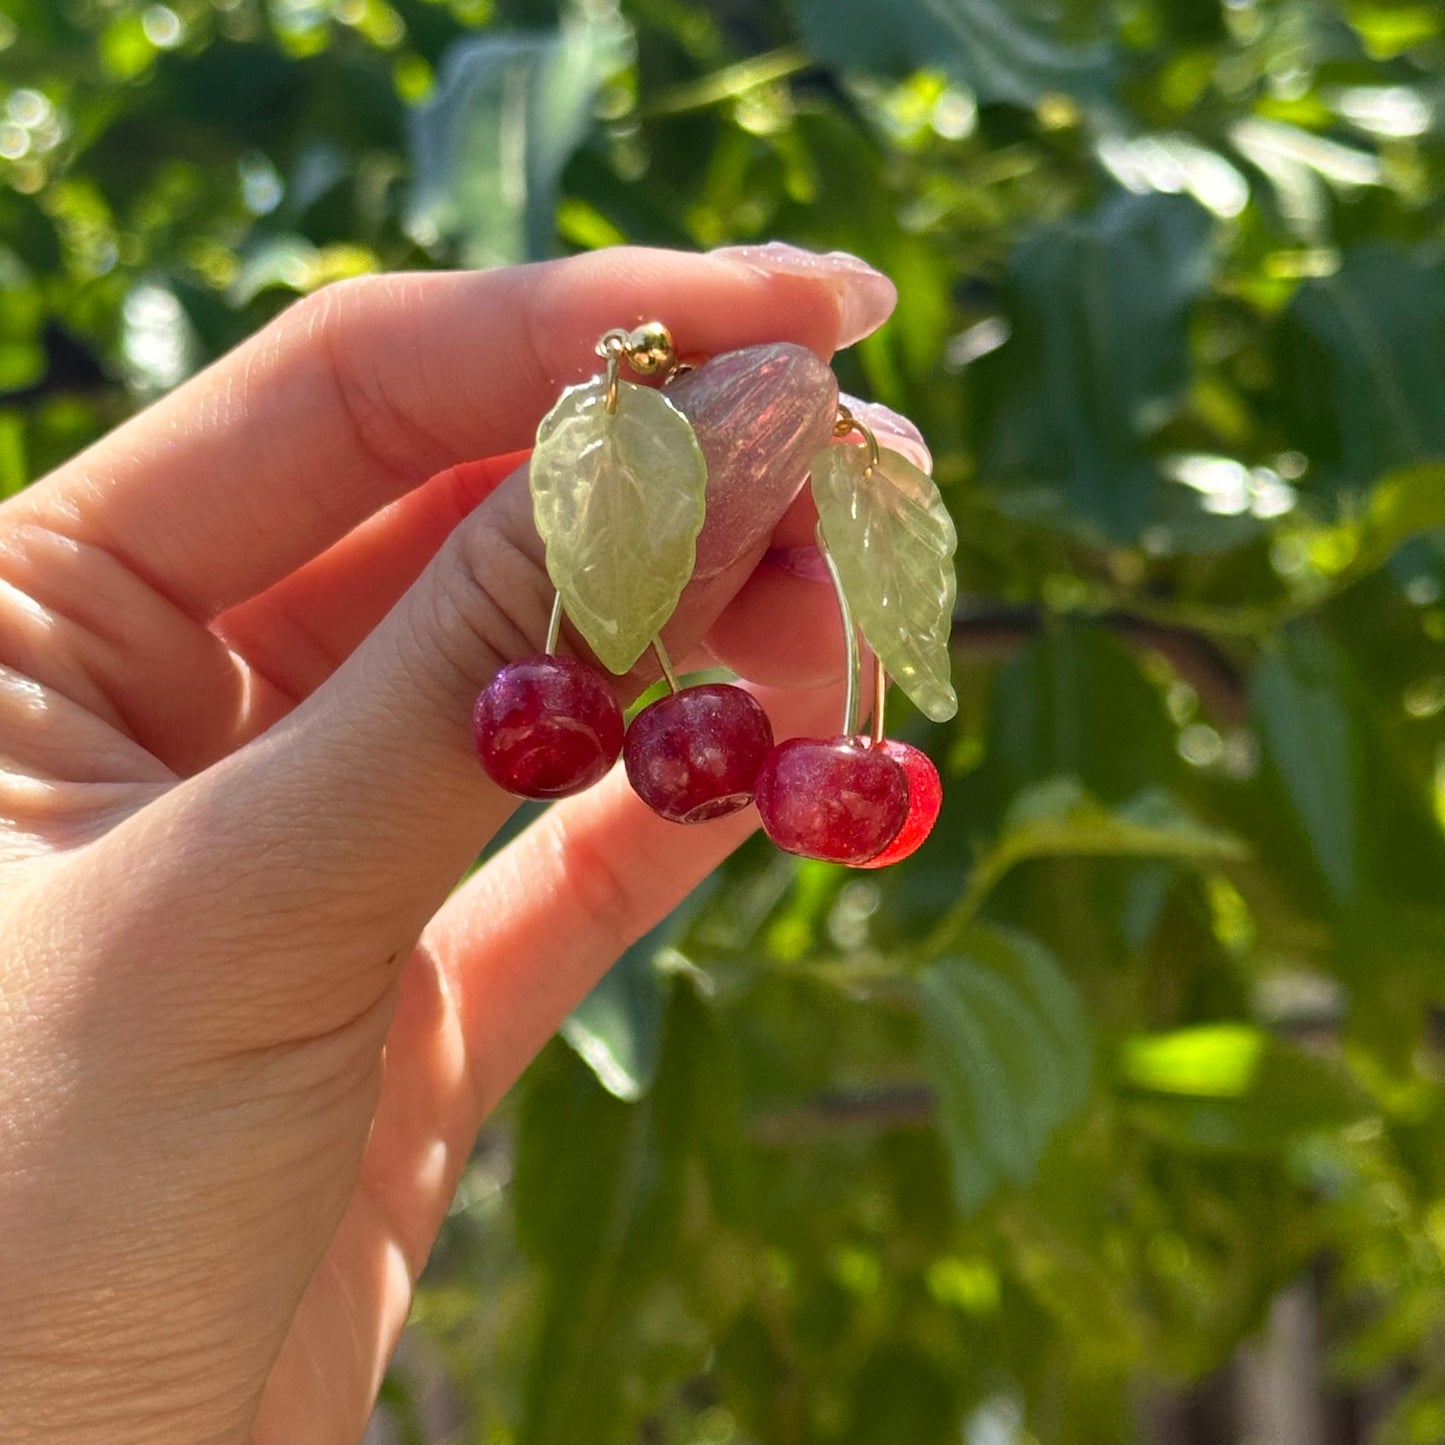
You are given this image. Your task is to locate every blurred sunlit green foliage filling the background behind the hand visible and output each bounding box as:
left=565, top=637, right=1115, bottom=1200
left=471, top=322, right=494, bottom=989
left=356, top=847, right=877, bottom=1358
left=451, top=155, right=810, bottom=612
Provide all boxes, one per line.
left=8, top=0, right=1445, bottom=1445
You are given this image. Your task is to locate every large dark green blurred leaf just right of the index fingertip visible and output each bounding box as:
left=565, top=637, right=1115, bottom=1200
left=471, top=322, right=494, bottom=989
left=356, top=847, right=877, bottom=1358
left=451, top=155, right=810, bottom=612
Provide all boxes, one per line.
left=971, top=194, right=1209, bottom=540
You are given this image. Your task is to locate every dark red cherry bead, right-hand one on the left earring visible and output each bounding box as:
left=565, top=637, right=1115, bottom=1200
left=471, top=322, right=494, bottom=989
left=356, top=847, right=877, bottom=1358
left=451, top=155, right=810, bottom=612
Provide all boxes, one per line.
left=623, top=682, right=773, bottom=822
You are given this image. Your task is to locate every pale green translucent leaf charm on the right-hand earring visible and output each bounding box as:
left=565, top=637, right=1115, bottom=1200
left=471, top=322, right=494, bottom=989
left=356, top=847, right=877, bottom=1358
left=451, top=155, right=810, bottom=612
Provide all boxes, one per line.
left=812, top=447, right=958, bottom=723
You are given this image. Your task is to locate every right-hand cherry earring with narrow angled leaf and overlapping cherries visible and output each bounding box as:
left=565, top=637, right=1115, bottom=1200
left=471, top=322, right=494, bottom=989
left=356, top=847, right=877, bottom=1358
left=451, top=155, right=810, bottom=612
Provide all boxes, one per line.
left=757, top=407, right=958, bottom=867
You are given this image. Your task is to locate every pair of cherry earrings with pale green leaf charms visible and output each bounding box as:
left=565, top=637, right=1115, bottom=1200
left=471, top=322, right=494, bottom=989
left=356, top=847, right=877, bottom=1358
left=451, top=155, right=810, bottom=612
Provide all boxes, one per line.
left=473, top=322, right=957, bottom=867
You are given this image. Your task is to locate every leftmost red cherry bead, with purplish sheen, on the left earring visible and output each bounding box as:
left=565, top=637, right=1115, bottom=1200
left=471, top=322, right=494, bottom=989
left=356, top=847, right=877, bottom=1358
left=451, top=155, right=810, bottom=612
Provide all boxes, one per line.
left=471, top=655, right=623, bottom=798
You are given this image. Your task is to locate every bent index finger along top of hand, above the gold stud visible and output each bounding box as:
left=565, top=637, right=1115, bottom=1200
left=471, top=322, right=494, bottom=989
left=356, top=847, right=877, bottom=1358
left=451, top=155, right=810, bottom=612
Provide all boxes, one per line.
left=13, top=247, right=892, bottom=620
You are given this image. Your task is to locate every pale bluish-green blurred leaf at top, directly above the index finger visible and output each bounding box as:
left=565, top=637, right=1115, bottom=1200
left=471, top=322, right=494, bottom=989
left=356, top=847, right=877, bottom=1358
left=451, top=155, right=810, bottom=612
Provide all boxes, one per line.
left=406, top=13, right=630, bottom=266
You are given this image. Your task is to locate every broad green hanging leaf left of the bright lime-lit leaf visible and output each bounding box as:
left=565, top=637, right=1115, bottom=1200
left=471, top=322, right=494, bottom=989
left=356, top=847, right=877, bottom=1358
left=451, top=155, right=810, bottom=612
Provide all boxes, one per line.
left=919, top=929, right=1090, bottom=1212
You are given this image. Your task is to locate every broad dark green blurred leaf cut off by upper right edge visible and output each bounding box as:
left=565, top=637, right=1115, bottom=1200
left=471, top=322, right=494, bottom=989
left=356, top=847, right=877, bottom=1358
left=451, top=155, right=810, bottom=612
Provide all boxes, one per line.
left=1276, top=243, right=1445, bottom=497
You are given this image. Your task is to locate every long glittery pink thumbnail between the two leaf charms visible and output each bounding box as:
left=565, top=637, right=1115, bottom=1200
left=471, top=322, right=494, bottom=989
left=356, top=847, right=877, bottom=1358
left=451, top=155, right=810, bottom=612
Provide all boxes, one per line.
left=668, top=341, right=838, bottom=578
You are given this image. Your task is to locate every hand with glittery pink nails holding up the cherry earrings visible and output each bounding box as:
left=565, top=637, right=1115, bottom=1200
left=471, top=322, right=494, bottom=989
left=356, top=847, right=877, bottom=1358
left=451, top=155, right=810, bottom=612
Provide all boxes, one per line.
left=0, top=250, right=892, bottom=1445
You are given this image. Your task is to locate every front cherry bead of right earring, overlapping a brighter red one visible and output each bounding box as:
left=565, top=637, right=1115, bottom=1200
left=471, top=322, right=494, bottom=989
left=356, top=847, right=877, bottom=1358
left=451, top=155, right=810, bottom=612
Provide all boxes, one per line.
left=757, top=737, right=907, bottom=866
